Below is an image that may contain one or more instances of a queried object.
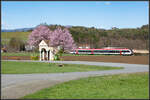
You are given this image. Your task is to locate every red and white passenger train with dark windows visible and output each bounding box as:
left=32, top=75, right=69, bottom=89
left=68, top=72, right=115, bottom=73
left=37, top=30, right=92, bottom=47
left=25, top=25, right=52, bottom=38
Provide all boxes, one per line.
left=70, top=48, right=133, bottom=55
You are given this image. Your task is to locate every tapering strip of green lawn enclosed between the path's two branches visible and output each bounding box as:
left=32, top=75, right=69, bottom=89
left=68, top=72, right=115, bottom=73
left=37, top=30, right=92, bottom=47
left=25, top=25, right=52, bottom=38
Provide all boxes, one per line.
left=1, top=61, right=123, bottom=74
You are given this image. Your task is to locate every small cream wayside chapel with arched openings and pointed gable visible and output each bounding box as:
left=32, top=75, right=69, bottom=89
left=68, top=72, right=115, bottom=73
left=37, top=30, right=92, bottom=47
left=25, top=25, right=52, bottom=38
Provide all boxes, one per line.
left=39, top=40, right=59, bottom=61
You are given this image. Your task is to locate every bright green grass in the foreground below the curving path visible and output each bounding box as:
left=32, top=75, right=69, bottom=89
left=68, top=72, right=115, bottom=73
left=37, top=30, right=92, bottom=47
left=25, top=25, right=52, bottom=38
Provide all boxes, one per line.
left=23, top=73, right=149, bottom=99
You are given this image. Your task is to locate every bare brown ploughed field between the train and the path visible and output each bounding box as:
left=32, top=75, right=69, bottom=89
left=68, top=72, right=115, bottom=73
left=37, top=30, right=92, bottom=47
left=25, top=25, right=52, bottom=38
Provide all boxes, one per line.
left=2, top=56, right=149, bottom=64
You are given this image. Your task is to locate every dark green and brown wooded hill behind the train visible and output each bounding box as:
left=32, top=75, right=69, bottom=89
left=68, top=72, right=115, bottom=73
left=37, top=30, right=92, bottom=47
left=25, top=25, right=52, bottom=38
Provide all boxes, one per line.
left=49, top=25, right=149, bottom=49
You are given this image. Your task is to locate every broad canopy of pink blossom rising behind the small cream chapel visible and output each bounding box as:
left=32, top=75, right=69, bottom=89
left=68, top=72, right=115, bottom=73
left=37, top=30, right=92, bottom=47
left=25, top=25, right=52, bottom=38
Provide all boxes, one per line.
left=28, top=25, right=76, bottom=51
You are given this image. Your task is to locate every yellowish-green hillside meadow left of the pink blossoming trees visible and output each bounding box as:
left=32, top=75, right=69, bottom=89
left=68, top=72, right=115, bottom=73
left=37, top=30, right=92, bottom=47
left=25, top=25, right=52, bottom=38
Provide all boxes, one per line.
left=1, top=32, right=31, bottom=44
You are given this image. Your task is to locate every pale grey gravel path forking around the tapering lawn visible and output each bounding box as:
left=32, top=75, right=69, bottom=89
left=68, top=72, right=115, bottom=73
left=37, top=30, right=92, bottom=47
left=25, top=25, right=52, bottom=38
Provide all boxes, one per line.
left=1, top=60, right=149, bottom=99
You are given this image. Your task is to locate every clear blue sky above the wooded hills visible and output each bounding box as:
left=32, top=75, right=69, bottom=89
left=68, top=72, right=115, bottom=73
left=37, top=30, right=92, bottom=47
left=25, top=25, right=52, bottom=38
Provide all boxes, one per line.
left=1, top=1, right=149, bottom=29
